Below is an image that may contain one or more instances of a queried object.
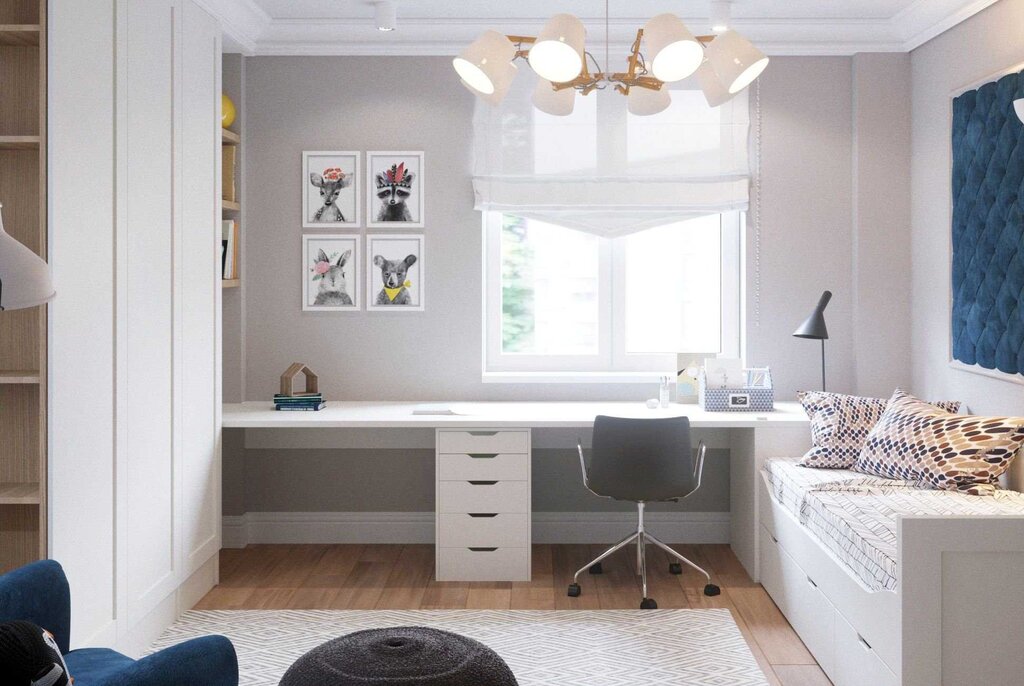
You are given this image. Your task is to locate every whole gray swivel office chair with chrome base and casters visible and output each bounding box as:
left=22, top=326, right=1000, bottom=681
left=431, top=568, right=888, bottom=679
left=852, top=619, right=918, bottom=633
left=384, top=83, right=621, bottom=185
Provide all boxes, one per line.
left=569, top=416, right=721, bottom=610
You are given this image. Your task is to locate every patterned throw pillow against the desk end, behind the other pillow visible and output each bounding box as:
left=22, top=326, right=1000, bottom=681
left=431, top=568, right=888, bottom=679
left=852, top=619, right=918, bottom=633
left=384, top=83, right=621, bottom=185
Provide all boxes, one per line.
left=798, top=391, right=959, bottom=469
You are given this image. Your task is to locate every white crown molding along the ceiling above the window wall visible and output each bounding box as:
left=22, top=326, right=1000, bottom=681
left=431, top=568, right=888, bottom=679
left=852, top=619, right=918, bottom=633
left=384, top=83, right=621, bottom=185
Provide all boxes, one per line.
left=209, top=0, right=997, bottom=57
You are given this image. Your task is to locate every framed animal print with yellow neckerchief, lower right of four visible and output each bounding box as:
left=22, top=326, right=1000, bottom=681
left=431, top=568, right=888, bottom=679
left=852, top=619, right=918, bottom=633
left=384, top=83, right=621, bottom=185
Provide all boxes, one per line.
left=367, top=233, right=425, bottom=312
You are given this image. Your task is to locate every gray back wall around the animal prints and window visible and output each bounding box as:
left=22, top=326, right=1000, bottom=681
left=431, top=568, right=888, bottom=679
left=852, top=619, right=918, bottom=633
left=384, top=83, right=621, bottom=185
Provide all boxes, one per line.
left=224, top=55, right=909, bottom=514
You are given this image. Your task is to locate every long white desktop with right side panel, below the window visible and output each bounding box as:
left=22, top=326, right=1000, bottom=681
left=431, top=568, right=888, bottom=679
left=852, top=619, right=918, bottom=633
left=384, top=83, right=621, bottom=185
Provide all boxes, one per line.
left=223, top=400, right=810, bottom=580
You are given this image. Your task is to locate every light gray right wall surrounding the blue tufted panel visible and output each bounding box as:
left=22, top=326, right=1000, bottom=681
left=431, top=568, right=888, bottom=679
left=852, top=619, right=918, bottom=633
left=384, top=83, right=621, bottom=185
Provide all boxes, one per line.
left=910, top=0, right=1024, bottom=430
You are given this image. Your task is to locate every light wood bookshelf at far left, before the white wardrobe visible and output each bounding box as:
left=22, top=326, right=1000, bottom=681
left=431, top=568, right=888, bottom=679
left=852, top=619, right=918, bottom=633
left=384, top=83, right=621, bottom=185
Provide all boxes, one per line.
left=0, top=0, right=47, bottom=573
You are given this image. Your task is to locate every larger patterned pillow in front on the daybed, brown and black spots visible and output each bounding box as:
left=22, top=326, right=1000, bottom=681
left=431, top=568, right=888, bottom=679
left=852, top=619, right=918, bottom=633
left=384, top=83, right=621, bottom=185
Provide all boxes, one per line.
left=853, top=389, right=1024, bottom=496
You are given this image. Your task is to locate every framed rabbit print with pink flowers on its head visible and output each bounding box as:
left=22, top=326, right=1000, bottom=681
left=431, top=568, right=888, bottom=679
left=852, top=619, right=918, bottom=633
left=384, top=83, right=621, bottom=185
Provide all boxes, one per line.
left=302, top=234, right=362, bottom=311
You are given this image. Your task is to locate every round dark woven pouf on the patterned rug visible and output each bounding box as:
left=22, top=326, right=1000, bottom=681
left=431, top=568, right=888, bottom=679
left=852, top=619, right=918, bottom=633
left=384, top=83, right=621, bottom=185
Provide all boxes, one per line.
left=281, top=627, right=518, bottom=686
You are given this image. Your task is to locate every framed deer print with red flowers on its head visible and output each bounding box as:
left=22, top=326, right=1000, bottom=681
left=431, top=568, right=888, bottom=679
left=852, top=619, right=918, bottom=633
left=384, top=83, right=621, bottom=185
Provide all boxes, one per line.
left=302, top=151, right=360, bottom=228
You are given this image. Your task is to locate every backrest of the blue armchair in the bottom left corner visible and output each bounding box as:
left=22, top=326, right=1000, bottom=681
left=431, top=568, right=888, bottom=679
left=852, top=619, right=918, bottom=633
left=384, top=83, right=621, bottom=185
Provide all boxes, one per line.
left=0, top=560, right=71, bottom=654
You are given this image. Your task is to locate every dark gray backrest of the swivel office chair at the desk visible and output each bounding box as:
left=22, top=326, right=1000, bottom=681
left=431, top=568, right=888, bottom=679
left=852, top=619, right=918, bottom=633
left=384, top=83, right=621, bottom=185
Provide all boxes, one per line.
left=588, top=416, right=698, bottom=502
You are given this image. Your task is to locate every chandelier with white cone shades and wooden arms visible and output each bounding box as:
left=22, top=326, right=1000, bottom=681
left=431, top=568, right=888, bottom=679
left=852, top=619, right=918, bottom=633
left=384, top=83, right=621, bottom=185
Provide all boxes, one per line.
left=452, top=0, right=768, bottom=116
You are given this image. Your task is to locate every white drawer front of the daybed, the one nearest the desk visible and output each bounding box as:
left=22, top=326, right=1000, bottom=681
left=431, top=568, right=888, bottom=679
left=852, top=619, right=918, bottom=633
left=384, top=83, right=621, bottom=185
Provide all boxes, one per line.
left=761, top=527, right=831, bottom=683
